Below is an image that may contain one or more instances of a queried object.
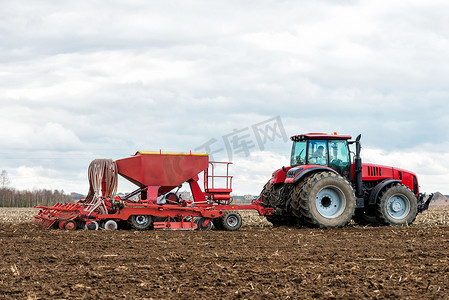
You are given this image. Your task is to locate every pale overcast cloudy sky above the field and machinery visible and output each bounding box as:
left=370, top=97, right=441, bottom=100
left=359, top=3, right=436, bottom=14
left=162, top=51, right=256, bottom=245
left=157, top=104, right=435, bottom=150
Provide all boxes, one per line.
left=0, top=0, right=449, bottom=194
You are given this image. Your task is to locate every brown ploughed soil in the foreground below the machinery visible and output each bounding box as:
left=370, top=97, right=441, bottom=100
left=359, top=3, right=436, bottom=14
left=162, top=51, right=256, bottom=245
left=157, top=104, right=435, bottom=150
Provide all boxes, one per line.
left=0, top=218, right=449, bottom=299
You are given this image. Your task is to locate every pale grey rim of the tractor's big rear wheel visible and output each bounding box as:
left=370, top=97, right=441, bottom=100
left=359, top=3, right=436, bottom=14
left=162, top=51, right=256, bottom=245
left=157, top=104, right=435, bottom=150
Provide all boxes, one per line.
left=316, top=187, right=346, bottom=218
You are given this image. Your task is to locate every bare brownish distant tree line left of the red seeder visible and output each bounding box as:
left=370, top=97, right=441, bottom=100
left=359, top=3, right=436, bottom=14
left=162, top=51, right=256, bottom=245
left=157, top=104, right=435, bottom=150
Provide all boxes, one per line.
left=0, top=188, right=74, bottom=207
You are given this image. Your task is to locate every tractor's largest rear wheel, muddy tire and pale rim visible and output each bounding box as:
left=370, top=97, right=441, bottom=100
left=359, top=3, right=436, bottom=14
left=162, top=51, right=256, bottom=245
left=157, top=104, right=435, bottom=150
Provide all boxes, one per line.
left=296, top=172, right=355, bottom=228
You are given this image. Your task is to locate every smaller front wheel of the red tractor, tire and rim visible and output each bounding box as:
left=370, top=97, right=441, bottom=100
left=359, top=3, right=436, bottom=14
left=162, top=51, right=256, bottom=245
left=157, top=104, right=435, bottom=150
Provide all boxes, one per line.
left=377, top=184, right=418, bottom=225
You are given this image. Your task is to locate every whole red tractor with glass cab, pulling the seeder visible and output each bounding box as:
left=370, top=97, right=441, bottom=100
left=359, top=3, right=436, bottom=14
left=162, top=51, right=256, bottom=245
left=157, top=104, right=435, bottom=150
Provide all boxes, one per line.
left=261, top=133, right=432, bottom=228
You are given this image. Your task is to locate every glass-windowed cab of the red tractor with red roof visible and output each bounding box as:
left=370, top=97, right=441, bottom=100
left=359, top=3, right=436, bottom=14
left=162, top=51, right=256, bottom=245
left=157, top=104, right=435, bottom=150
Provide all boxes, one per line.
left=290, top=133, right=351, bottom=180
